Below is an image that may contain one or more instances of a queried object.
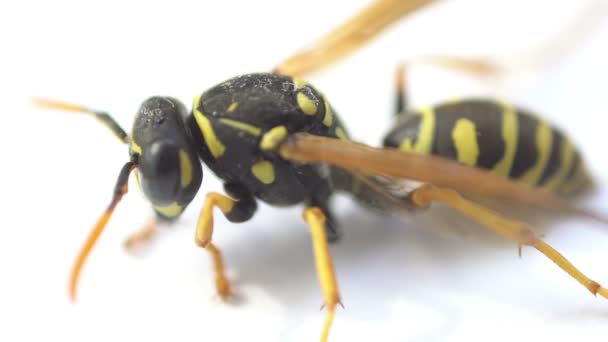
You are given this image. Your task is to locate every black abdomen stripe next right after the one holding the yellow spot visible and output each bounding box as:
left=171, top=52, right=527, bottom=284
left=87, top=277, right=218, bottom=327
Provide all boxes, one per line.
left=509, top=111, right=540, bottom=178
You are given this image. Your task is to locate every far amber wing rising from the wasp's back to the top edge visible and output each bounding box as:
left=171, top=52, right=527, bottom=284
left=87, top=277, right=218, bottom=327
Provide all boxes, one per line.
left=275, top=0, right=433, bottom=76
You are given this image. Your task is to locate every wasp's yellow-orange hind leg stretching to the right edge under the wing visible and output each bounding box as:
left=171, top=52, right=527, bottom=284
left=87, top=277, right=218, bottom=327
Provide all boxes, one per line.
left=411, top=184, right=608, bottom=299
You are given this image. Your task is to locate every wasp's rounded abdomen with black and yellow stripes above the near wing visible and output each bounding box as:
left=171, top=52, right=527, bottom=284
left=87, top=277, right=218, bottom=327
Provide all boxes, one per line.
left=384, top=100, right=588, bottom=193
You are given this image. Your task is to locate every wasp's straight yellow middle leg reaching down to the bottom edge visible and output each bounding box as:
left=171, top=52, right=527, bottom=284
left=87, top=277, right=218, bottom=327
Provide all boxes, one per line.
left=304, top=207, right=340, bottom=342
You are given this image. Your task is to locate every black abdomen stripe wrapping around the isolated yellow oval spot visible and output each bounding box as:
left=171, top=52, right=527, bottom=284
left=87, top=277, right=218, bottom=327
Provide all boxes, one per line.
left=432, top=100, right=506, bottom=169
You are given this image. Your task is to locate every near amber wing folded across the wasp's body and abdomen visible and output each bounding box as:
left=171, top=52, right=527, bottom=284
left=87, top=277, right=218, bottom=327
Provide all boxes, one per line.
left=280, top=133, right=608, bottom=224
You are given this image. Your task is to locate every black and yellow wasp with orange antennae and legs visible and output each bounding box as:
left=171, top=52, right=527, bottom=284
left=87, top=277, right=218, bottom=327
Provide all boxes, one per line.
left=37, top=0, right=608, bottom=341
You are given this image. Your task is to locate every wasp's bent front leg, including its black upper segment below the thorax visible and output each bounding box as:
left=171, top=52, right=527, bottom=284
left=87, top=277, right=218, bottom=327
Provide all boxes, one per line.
left=195, top=184, right=257, bottom=299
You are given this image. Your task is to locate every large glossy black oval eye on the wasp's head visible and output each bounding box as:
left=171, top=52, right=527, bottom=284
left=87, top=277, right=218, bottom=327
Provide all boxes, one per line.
left=139, top=141, right=180, bottom=205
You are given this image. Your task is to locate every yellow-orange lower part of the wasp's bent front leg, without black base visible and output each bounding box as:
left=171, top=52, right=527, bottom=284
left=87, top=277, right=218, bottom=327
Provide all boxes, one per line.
left=195, top=192, right=236, bottom=299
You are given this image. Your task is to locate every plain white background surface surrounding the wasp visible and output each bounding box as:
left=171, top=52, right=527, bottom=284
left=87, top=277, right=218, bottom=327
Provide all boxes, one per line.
left=0, top=0, right=608, bottom=341
